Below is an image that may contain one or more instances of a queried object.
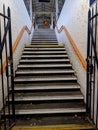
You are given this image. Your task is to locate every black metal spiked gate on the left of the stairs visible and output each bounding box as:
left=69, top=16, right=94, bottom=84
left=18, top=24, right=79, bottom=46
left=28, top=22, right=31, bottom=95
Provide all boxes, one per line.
left=0, top=5, right=15, bottom=130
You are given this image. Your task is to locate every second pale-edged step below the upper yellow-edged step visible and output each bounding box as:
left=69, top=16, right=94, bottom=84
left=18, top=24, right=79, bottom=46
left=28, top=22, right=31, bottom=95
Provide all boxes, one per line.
left=22, top=51, right=67, bottom=55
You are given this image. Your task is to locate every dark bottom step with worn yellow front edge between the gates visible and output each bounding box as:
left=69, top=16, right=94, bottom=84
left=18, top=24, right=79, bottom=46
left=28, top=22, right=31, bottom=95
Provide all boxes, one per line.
left=12, top=114, right=94, bottom=130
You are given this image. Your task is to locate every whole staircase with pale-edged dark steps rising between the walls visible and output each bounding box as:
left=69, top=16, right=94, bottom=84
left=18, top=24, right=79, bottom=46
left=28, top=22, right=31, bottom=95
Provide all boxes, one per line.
left=9, top=30, right=92, bottom=130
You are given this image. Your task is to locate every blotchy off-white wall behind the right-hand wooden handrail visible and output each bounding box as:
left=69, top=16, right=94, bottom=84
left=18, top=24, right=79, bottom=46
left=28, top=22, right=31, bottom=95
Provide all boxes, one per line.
left=56, top=0, right=89, bottom=99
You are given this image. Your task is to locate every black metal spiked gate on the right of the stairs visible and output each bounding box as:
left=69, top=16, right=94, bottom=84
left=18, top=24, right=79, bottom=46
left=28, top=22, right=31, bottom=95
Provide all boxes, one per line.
left=86, top=1, right=98, bottom=128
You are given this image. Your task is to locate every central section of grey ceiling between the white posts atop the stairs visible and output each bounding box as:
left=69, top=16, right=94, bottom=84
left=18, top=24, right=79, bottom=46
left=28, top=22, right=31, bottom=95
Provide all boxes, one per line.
left=33, top=0, right=55, bottom=25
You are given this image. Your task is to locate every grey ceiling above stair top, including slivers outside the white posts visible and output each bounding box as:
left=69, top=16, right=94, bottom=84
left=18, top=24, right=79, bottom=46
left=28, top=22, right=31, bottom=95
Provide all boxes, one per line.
left=24, top=0, right=65, bottom=25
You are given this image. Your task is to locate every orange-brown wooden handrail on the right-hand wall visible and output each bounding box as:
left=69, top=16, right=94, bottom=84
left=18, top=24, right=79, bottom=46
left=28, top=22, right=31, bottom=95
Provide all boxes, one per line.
left=55, top=22, right=87, bottom=70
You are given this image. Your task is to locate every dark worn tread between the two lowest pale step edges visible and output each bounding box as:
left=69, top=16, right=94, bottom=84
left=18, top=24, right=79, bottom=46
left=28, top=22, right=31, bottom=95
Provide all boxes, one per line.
left=13, top=100, right=85, bottom=107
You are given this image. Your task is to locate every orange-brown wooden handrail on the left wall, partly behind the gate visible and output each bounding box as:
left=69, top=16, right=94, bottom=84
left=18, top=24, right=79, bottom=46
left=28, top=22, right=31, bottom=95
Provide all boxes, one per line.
left=0, top=19, right=34, bottom=74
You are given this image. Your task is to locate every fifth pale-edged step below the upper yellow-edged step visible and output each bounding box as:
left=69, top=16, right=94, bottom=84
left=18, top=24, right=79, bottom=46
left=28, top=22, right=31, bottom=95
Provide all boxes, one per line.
left=18, top=64, right=72, bottom=69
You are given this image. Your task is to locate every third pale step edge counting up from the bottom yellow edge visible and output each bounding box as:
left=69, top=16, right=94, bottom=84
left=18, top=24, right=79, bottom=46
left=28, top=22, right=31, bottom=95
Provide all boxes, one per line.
left=15, top=83, right=80, bottom=92
